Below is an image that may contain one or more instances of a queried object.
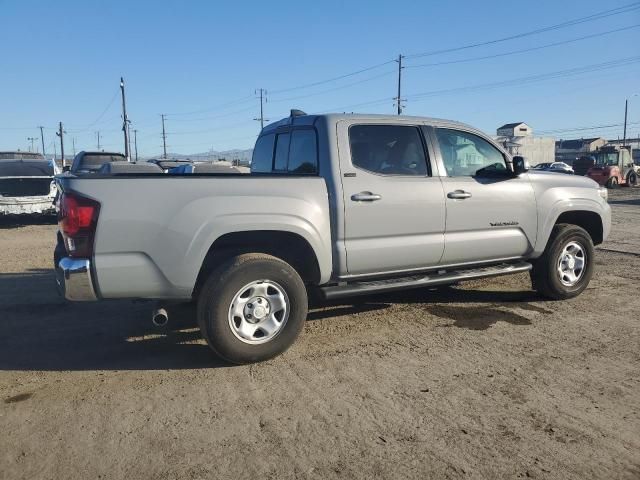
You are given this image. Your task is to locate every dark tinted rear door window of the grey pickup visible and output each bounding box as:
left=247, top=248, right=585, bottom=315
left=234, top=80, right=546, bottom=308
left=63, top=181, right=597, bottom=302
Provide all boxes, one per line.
left=349, top=125, right=427, bottom=176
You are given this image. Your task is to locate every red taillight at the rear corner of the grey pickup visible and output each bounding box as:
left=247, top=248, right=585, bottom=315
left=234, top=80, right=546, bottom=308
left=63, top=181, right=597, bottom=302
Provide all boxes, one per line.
left=58, top=193, right=100, bottom=257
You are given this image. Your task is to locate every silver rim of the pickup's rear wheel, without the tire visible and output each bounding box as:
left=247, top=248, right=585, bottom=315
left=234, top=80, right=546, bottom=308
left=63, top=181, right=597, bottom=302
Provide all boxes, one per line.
left=229, top=280, right=290, bottom=345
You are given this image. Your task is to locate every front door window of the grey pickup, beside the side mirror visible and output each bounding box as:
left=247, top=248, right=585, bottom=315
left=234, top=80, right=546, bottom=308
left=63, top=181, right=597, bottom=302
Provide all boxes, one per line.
left=436, top=128, right=507, bottom=177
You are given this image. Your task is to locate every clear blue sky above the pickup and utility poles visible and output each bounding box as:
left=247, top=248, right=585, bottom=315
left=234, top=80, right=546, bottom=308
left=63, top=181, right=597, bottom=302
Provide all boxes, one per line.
left=0, top=0, right=640, bottom=155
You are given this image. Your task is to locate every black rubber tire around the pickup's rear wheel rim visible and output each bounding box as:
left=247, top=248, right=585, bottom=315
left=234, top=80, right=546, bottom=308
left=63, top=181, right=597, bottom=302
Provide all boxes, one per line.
left=197, top=253, right=308, bottom=364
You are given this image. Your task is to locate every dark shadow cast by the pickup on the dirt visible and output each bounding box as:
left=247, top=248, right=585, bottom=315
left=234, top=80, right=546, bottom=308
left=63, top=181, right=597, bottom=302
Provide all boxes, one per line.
left=0, top=270, right=550, bottom=371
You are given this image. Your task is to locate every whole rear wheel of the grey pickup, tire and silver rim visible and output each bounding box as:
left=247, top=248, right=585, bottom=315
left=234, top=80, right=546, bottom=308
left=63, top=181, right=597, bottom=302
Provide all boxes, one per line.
left=198, top=253, right=308, bottom=364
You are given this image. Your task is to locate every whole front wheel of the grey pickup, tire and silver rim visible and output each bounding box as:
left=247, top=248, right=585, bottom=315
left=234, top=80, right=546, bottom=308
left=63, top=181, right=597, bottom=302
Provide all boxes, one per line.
left=531, top=224, right=594, bottom=300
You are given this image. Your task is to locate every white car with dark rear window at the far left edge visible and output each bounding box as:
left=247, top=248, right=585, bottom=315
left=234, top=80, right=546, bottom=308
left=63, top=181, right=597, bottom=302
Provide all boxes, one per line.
left=0, top=151, right=59, bottom=215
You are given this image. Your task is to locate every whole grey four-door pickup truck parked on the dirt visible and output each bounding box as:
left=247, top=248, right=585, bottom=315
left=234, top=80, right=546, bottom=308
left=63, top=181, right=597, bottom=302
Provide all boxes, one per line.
left=55, top=111, right=611, bottom=363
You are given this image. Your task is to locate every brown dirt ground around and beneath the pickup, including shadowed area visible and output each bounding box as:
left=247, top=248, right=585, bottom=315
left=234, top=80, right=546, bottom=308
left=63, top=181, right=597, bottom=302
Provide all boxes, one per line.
left=0, top=189, right=640, bottom=480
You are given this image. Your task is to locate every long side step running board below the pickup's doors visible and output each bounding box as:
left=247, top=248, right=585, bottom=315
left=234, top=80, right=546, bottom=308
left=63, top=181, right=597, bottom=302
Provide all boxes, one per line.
left=320, top=262, right=532, bottom=300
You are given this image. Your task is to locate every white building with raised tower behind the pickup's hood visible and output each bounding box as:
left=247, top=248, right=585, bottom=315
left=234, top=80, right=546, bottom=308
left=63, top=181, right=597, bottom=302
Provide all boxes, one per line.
left=494, top=122, right=556, bottom=166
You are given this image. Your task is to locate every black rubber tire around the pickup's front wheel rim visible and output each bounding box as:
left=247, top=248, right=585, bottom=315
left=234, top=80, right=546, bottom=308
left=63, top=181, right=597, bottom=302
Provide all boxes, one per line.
left=531, top=224, right=594, bottom=300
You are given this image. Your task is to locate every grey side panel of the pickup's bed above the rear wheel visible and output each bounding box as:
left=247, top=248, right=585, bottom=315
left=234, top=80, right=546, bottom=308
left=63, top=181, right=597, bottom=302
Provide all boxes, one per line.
left=58, top=174, right=332, bottom=299
